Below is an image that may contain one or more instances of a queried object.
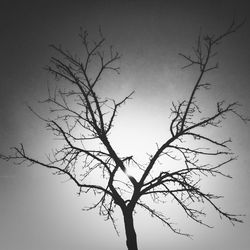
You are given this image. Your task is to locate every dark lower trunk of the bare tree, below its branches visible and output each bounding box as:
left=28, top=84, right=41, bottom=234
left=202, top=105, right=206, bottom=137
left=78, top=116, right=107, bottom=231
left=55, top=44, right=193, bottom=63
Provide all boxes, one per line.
left=123, top=210, right=138, bottom=250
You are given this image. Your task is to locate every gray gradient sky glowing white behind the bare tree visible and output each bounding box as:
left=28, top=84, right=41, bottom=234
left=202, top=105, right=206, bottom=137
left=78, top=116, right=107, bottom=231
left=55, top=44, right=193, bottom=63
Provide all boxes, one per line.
left=0, top=0, right=250, bottom=250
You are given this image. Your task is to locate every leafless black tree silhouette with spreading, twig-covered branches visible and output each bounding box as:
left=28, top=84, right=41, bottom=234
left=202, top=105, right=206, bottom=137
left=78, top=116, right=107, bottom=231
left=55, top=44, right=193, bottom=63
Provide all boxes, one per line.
left=1, top=22, right=248, bottom=250
